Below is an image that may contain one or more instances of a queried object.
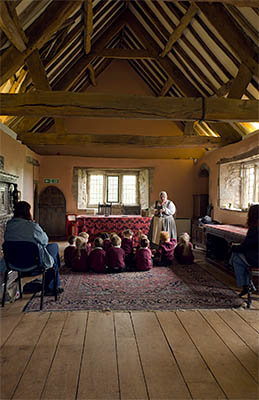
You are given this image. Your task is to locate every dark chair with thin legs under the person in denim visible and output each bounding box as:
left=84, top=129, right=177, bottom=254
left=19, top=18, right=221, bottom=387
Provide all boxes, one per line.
left=2, top=241, right=57, bottom=310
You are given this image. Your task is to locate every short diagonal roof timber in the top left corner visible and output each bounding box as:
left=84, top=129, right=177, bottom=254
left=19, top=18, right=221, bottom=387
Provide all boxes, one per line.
left=0, top=1, right=28, bottom=53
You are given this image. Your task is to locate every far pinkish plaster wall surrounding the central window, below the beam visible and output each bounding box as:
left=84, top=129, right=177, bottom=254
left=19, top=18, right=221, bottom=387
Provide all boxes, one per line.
left=39, top=156, right=194, bottom=218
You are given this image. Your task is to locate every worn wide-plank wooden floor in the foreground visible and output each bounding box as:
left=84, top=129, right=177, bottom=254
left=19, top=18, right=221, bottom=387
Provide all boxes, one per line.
left=1, top=245, right=259, bottom=400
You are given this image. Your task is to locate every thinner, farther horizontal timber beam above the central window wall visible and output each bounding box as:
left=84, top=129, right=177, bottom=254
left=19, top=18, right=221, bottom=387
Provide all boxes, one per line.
left=19, top=132, right=221, bottom=148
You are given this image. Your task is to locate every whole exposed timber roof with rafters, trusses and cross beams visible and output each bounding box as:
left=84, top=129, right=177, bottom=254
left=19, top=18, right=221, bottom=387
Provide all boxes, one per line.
left=0, top=0, right=259, bottom=159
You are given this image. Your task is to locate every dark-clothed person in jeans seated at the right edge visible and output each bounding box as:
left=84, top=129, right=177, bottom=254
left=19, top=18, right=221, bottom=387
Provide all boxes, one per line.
left=229, top=204, right=259, bottom=297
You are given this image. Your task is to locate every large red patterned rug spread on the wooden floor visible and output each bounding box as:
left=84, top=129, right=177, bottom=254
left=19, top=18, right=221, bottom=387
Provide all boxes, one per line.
left=24, top=264, right=242, bottom=312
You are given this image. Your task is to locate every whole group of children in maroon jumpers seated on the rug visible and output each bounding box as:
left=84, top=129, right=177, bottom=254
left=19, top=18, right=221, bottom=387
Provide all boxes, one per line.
left=64, top=229, right=194, bottom=273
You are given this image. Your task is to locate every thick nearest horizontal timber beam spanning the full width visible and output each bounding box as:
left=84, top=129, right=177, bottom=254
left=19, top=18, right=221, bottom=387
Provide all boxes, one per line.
left=0, top=92, right=259, bottom=122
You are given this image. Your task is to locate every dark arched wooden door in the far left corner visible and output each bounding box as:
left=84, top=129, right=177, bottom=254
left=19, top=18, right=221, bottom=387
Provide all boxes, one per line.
left=39, top=186, right=66, bottom=240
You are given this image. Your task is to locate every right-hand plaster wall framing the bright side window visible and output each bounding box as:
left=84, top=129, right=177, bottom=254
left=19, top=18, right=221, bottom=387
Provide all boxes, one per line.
left=195, top=133, right=259, bottom=225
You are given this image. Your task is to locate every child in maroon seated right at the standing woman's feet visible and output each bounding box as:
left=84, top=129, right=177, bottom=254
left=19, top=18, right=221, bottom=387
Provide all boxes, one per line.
left=154, top=231, right=176, bottom=266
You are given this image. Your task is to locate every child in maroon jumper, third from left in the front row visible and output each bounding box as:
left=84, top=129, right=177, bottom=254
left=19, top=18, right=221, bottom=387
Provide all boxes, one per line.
left=106, top=235, right=126, bottom=272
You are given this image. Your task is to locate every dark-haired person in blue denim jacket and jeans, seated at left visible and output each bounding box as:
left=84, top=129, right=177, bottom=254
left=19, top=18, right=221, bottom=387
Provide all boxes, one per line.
left=1, top=201, right=63, bottom=295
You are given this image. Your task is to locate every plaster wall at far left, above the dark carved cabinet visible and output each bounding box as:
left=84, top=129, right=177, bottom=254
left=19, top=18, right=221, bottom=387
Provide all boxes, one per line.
left=0, top=129, right=41, bottom=212
